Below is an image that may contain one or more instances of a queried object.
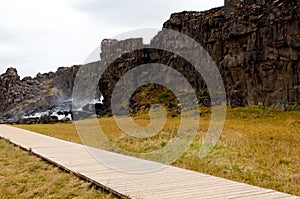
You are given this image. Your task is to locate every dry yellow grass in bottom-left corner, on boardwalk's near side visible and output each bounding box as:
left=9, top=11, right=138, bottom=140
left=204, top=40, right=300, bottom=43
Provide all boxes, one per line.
left=0, top=139, right=116, bottom=199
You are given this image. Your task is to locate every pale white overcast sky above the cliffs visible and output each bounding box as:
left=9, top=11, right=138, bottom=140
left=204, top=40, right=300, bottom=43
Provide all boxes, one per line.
left=0, top=0, right=224, bottom=77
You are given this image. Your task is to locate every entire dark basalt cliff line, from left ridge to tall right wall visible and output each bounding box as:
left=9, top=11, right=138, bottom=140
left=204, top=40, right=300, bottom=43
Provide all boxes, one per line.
left=0, top=0, right=300, bottom=119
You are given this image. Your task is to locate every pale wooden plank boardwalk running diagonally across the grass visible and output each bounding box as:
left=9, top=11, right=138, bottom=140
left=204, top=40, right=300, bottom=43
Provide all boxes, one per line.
left=0, top=125, right=300, bottom=199
